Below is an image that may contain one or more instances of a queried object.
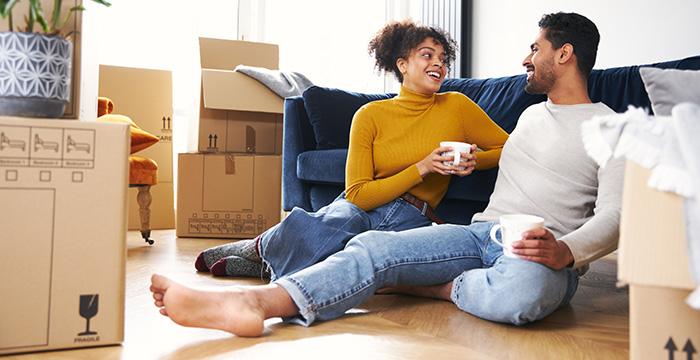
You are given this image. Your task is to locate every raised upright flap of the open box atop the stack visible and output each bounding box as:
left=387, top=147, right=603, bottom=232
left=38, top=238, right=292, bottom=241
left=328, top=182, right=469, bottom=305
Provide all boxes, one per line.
left=199, top=37, right=279, bottom=71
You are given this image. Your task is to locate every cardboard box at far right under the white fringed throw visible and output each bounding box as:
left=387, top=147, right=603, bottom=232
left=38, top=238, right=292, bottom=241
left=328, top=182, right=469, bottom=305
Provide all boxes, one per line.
left=618, top=162, right=700, bottom=359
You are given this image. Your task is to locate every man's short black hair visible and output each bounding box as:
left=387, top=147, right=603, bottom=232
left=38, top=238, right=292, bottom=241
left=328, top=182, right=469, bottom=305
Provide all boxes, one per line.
left=538, top=12, right=600, bottom=79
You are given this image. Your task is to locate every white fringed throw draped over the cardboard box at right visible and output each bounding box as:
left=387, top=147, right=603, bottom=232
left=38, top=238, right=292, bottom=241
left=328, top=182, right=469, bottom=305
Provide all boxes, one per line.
left=581, top=103, right=700, bottom=309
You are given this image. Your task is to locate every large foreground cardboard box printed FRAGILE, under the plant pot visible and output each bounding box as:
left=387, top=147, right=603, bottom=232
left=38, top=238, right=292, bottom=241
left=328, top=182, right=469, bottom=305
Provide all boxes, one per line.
left=0, top=117, right=129, bottom=354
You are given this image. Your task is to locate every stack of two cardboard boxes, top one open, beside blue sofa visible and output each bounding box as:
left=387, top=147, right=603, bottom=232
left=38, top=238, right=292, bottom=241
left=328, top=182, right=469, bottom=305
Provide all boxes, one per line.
left=177, top=38, right=283, bottom=238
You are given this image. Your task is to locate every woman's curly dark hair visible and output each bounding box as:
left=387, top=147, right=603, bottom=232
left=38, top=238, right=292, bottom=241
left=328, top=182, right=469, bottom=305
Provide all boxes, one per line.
left=368, top=20, right=457, bottom=82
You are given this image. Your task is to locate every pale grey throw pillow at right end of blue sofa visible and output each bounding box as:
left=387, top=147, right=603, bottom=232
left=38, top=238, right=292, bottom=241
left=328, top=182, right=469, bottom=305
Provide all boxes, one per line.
left=639, top=67, right=700, bottom=116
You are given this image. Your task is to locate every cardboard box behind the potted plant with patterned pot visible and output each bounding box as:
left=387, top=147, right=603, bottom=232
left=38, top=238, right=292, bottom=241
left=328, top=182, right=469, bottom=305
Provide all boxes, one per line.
left=0, top=0, right=86, bottom=119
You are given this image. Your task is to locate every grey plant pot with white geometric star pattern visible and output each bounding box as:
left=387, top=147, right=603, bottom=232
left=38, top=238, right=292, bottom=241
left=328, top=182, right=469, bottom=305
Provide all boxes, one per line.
left=0, top=32, right=73, bottom=118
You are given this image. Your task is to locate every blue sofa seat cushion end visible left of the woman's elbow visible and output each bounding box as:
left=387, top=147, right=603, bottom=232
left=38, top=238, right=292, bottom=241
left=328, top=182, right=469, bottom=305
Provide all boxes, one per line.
left=297, top=149, right=348, bottom=185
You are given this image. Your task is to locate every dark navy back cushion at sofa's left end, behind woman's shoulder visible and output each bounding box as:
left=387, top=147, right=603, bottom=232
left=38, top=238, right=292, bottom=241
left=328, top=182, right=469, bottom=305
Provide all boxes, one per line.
left=302, top=86, right=395, bottom=150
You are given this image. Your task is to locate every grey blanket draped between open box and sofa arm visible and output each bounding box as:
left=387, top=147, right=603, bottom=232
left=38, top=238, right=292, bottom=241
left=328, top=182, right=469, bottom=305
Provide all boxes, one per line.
left=234, top=65, right=314, bottom=98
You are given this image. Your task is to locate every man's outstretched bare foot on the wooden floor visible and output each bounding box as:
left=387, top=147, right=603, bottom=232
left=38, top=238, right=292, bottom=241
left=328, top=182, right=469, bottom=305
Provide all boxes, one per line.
left=151, top=274, right=265, bottom=336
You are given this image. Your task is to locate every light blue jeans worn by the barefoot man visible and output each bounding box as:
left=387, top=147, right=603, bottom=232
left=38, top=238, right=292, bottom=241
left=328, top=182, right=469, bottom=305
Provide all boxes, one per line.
left=275, top=222, right=578, bottom=326
